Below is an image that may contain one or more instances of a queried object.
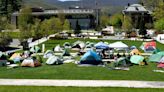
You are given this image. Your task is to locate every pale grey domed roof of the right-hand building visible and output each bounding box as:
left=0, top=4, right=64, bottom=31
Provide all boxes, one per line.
left=123, top=4, right=150, bottom=13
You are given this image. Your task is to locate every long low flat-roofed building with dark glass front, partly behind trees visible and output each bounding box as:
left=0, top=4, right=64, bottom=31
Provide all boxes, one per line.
left=11, top=7, right=100, bottom=29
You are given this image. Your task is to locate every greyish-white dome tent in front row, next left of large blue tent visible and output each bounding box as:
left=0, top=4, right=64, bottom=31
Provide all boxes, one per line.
left=46, top=56, right=63, bottom=65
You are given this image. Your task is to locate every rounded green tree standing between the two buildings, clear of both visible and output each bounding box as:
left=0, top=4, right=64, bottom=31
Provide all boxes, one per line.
left=110, top=14, right=123, bottom=28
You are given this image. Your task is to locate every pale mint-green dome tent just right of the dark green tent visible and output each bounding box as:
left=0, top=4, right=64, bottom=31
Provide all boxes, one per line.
left=130, top=55, right=144, bottom=64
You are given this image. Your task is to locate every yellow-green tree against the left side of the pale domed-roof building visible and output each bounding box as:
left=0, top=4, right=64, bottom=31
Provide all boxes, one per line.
left=122, top=16, right=133, bottom=33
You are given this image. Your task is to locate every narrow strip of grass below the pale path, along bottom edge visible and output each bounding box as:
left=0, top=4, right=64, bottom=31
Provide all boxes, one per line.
left=0, top=86, right=164, bottom=92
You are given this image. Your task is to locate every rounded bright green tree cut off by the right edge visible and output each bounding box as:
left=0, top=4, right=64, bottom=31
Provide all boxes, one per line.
left=154, top=18, right=164, bottom=32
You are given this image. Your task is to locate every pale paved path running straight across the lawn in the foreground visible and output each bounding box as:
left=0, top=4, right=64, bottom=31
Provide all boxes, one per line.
left=0, top=79, right=164, bottom=88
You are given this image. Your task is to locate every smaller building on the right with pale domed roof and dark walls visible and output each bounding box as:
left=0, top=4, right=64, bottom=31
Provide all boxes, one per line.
left=122, top=4, right=153, bottom=29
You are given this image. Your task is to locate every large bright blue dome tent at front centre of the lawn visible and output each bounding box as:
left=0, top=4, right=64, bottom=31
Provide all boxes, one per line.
left=80, top=50, right=102, bottom=65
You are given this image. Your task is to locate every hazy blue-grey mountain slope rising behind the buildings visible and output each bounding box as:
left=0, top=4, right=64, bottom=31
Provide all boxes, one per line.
left=24, top=0, right=139, bottom=14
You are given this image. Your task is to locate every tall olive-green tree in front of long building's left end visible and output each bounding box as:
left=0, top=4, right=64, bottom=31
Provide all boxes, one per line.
left=18, top=7, right=32, bottom=41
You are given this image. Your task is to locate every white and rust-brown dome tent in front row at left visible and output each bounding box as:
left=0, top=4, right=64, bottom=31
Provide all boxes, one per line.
left=21, top=57, right=41, bottom=67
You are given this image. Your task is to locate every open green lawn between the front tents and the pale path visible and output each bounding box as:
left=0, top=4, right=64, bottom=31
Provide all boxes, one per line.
left=0, top=64, right=164, bottom=81
